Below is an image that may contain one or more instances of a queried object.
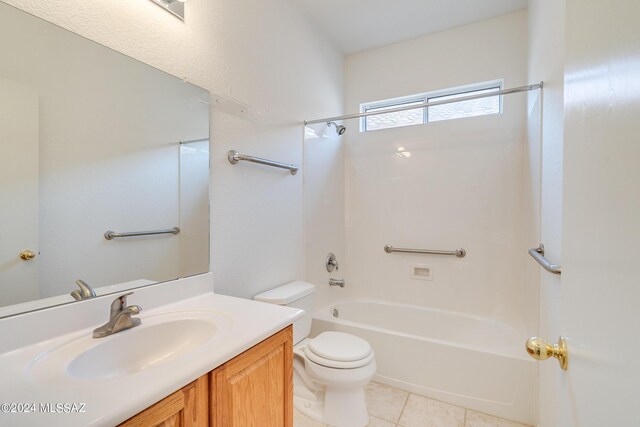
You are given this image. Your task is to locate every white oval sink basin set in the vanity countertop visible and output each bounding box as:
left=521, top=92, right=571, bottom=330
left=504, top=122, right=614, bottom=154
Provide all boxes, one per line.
left=28, top=311, right=230, bottom=384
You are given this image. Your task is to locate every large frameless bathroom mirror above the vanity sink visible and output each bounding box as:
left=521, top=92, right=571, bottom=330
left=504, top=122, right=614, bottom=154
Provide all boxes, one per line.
left=0, top=2, right=209, bottom=317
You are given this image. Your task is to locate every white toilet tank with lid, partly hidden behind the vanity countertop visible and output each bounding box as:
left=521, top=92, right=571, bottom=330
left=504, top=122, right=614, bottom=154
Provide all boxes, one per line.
left=253, top=281, right=316, bottom=344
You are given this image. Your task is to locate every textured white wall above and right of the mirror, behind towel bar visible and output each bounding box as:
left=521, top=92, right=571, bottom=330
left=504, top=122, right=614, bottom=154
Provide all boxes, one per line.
left=2, top=0, right=342, bottom=297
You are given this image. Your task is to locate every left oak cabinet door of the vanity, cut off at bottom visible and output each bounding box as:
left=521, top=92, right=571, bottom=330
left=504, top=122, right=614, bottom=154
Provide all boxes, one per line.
left=120, top=374, right=209, bottom=427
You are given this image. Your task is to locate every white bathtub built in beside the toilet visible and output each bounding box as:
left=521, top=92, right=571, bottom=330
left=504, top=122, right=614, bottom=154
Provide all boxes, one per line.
left=312, top=300, right=536, bottom=425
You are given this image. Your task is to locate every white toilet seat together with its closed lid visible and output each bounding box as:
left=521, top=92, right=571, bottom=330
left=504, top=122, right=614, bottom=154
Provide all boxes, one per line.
left=304, top=331, right=374, bottom=369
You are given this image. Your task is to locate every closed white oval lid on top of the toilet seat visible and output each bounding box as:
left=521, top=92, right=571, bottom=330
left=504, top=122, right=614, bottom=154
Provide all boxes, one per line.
left=307, top=331, right=373, bottom=362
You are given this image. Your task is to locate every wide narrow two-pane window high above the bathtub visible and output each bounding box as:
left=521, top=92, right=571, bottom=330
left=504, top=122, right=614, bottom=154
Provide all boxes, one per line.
left=360, top=81, right=502, bottom=132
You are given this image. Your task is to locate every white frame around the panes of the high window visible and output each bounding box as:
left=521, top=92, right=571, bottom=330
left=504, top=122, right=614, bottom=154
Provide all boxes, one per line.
left=360, top=79, right=504, bottom=133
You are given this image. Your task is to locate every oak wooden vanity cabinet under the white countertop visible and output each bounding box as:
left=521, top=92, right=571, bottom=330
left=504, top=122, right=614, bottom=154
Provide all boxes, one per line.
left=120, top=326, right=293, bottom=427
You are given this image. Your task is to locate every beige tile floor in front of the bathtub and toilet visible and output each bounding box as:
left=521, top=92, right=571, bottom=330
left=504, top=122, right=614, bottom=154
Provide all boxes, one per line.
left=293, top=382, right=528, bottom=427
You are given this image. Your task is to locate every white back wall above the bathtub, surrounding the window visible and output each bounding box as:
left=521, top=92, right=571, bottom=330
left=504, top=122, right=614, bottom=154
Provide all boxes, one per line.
left=345, top=12, right=527, bottom=321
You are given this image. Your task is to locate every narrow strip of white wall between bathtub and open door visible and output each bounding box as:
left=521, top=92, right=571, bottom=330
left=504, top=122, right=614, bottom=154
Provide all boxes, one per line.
left=527, top=0, right=565, bottom=427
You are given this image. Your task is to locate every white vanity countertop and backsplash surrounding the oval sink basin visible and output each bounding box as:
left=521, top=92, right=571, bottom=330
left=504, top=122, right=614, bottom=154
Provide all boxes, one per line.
left=0, top=273, right=302, bottom=426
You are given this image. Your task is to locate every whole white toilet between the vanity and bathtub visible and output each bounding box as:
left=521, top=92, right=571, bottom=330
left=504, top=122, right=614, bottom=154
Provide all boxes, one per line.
left=254, top=281, right=376, bottom=427
